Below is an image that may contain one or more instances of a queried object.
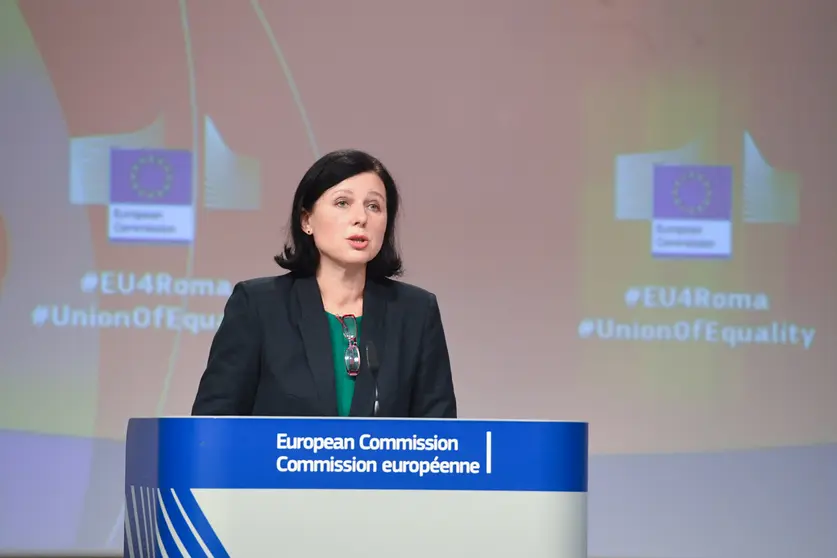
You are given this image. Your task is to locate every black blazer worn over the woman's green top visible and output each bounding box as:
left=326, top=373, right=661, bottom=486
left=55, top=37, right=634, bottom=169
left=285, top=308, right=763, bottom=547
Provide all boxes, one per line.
left=192, top=273, right=456, bottom=418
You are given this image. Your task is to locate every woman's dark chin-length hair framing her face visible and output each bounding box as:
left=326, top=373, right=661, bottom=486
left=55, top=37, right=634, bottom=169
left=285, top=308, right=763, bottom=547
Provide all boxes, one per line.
left=273, top=149, right=403, bottom=279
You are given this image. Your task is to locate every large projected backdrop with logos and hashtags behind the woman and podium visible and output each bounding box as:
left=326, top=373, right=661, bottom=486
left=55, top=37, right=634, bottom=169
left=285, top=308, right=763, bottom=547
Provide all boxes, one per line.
left=0, top=0, right=837, bottom=558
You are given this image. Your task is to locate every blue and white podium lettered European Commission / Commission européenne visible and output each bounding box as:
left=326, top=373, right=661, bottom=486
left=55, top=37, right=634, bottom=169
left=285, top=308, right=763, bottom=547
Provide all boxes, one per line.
left=124, top=417, right=588, bottom=558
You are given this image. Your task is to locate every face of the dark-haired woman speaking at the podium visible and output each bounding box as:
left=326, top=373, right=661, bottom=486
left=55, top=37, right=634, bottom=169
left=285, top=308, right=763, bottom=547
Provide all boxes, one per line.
left=302, top=172, right=387, bottom=267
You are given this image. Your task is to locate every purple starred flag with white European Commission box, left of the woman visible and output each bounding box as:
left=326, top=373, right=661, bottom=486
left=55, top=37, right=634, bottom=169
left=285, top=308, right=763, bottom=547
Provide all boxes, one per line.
left=108, top=149, right=195, bottom=243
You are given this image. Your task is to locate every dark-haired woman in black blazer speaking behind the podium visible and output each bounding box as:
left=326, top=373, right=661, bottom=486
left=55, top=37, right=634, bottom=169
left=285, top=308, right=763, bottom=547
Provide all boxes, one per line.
left=192, top=150, right=456, bottom=418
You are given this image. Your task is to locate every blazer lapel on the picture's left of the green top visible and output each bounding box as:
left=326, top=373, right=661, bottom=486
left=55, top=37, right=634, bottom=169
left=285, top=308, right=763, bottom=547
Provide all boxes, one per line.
left=297, top=277, right=334, bottom=416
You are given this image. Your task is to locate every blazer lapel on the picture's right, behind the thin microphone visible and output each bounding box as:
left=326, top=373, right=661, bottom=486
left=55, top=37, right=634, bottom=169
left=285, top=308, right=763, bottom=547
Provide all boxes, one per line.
left=349, top=281, right=387, bottom=417
